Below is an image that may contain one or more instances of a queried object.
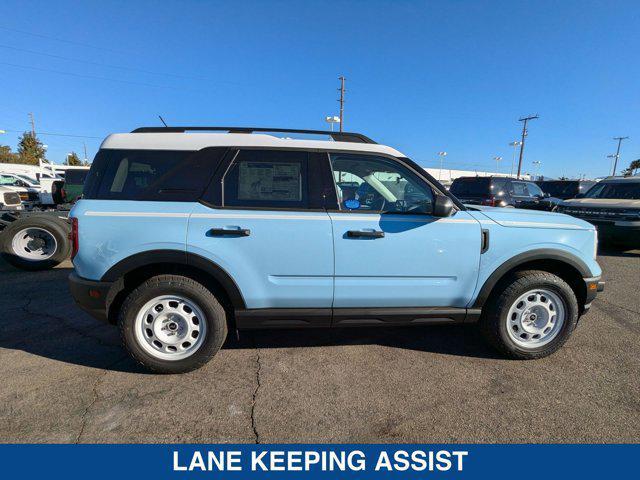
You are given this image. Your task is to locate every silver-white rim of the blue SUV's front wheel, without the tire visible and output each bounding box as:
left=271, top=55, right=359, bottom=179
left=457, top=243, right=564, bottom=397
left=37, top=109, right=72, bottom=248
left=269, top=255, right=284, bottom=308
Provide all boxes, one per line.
left=506, top=288, right=567, bottom=349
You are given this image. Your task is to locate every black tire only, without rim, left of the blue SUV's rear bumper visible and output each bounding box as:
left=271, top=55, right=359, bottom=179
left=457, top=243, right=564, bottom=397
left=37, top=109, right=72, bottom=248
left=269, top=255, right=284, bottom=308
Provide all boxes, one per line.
left=0, top=215, right=71, bottom=271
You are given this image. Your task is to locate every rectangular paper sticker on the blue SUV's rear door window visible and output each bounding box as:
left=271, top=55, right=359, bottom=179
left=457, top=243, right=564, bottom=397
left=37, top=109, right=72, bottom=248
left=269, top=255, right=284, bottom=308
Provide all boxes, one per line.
left=238, top=162, right=302, bottom=202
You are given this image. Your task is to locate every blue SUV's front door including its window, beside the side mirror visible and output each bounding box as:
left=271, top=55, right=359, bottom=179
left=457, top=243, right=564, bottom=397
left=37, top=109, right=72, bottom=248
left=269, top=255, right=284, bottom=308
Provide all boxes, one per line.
left=329, top=153, right=481, bottom=312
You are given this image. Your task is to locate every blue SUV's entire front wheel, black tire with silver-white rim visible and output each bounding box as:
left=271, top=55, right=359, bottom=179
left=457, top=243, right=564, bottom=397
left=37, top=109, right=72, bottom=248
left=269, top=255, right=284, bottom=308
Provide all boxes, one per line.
left=480, top=270, right=578, bottom=359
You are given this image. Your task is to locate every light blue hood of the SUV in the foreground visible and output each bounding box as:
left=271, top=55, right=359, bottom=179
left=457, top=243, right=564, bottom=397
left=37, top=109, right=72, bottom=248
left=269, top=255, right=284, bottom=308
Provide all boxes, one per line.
left=469, top=205, right=595, bottom=230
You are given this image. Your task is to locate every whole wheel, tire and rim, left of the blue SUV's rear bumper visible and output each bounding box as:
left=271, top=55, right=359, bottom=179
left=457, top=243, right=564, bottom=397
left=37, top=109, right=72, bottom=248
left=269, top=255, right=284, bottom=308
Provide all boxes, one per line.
left=0, top=214, right=71, bottom=270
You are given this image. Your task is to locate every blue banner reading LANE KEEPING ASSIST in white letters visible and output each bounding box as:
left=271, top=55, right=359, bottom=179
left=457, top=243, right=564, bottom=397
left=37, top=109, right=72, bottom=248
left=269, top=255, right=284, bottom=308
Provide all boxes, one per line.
left=0, top=444, right=640, bottom=480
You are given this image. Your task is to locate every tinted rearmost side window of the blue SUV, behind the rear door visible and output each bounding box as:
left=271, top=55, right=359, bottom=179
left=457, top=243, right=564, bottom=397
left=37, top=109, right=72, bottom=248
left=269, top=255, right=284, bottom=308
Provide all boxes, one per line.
left=85, top=148, right=226, bottom=202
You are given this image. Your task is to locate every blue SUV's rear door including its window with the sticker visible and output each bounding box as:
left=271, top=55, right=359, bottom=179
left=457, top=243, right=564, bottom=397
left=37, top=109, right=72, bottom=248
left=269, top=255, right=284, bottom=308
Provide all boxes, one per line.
left=187, top=149, right=335, bottom=326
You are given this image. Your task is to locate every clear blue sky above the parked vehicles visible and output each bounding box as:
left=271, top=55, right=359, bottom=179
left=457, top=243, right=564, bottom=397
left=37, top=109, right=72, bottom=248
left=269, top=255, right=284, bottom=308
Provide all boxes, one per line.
left=0, top=0, right=640, bottom=177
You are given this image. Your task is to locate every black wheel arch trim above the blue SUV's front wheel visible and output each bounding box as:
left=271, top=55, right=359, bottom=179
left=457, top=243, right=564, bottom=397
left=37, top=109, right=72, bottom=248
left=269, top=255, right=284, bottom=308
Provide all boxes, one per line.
left=473, top=248, right=592, bottom=308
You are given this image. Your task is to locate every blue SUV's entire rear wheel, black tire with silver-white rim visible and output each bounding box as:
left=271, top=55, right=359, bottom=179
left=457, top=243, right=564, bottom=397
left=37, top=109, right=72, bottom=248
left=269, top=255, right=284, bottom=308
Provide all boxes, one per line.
left=119, top=275, right=227, bottom=373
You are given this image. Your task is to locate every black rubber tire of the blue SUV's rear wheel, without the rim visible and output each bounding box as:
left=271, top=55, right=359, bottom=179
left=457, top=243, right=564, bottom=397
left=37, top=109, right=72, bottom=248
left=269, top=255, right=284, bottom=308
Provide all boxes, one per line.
left=118, top=275, right=227, bottom=373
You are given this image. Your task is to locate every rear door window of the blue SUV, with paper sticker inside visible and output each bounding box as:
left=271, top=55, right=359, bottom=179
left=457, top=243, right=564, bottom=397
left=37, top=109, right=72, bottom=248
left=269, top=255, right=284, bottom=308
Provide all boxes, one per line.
left=223, top=150, right=309, bottom=209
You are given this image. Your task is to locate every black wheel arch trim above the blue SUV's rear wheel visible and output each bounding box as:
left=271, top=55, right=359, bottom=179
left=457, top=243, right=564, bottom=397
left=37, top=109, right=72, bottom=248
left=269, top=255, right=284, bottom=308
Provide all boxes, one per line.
left=100, top=250, right=245, bottom=309
